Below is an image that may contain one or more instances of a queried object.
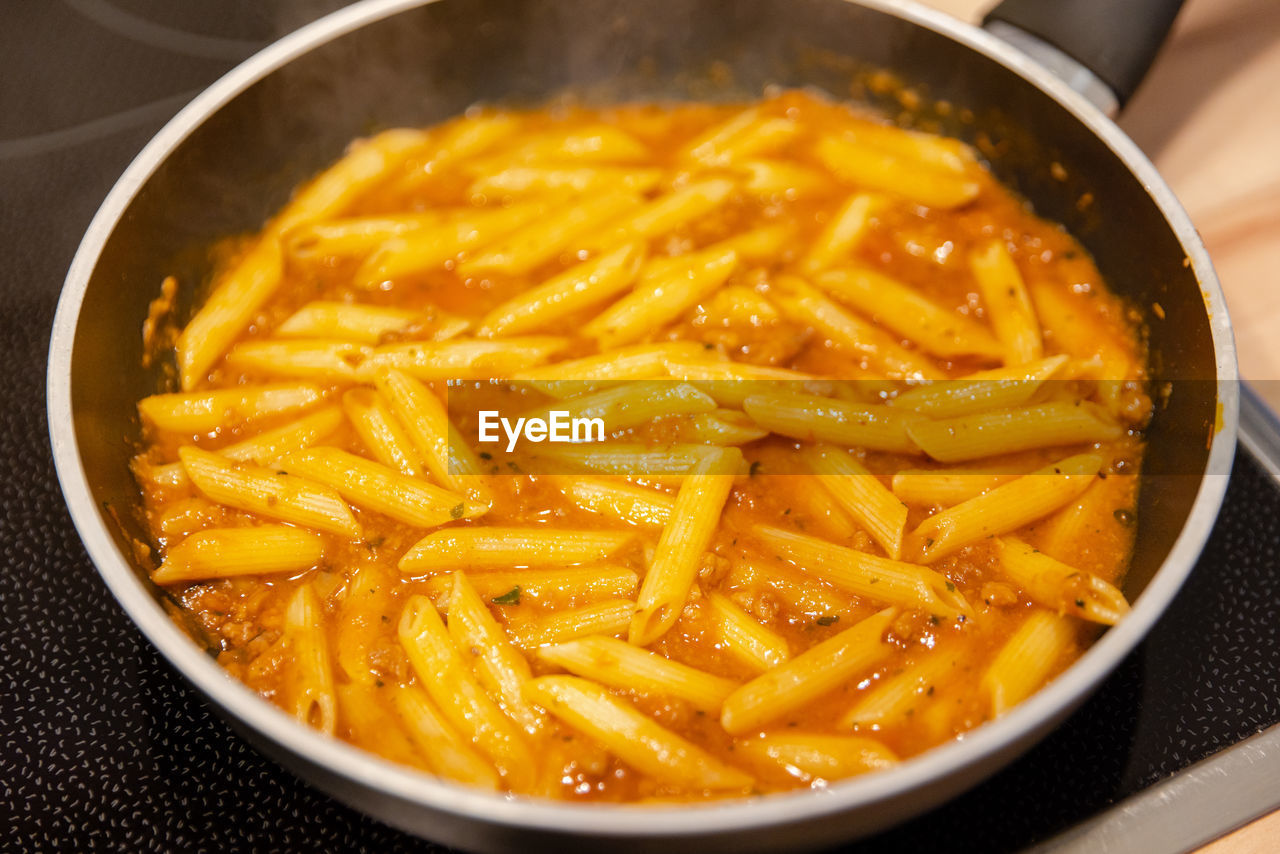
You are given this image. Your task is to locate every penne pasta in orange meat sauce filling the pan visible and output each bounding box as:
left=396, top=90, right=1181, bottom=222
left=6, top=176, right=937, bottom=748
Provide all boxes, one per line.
left=134, top=92, right=1151, bottom=802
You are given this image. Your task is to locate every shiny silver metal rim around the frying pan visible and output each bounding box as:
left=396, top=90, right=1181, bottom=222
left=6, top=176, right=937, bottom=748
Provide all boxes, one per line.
left=46, top=0, right=1239, bottom=839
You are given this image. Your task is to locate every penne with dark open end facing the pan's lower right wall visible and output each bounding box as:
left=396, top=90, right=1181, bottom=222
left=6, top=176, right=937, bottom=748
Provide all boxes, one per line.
left=995, top=535, right=1129, bottom=626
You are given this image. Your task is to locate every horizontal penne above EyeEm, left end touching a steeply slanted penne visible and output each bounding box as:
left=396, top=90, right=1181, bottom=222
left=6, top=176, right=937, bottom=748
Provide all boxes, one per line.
left=353, top=335, right=568, bottom=382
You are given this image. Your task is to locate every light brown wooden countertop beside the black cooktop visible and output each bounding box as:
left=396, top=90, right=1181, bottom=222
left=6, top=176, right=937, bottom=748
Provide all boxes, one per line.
left=924, top=0, right=1280, bottom=854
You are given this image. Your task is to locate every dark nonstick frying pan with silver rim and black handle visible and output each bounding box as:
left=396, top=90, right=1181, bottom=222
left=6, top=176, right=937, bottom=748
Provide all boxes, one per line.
left=49, top=0, right=1239, bottom=851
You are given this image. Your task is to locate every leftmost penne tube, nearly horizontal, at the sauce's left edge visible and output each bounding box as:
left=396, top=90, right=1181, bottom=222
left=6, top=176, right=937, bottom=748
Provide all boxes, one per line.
left=138, top=383, right=324, bottom=434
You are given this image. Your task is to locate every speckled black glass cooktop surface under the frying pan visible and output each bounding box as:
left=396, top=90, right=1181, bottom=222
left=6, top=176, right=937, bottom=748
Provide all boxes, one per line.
left=0, top=0, right=1280, bottom=851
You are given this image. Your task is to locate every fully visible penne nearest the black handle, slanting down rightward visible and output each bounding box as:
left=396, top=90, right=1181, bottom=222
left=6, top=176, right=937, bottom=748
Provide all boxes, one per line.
left=814, top=136, right=982, bottom=209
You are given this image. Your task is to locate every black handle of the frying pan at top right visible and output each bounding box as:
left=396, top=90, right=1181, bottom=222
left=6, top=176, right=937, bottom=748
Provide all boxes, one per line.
left=983, top=0, right=1183, bottom=105
